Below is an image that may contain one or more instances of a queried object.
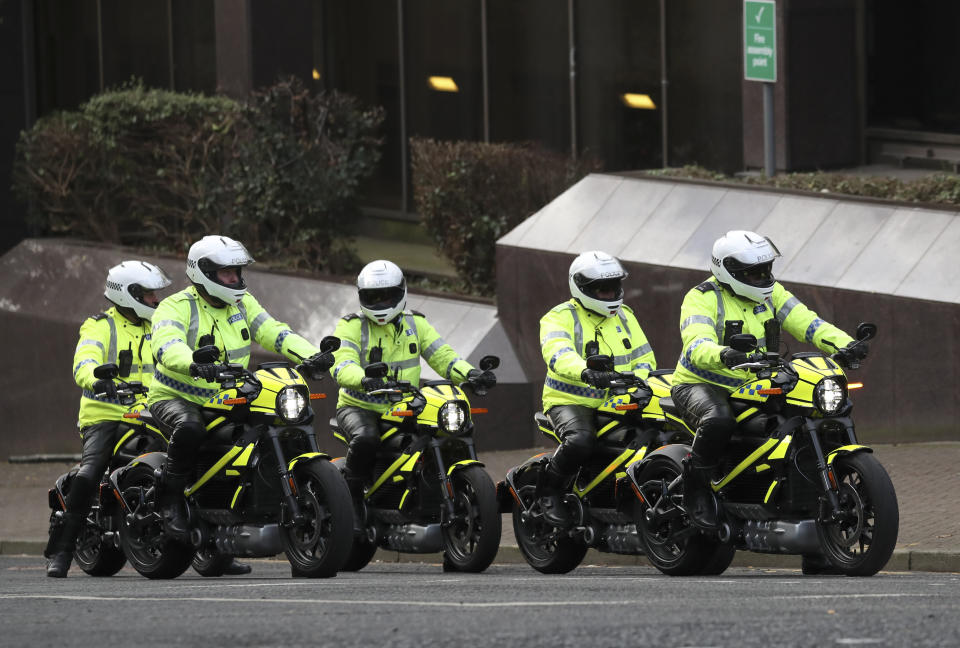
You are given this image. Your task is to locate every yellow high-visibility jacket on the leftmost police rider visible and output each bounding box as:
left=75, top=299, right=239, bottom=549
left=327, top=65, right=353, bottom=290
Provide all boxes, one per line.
left=73, top=306, right=153, bottom=428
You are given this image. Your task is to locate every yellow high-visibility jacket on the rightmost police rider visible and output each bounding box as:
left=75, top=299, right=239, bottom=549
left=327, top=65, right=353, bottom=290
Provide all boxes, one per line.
left=673, top=277, right=853, bottom=391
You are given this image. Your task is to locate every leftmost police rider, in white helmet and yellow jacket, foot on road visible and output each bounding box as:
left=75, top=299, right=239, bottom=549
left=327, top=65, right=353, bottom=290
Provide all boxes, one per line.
left=44, top=261, right=170, bottom=578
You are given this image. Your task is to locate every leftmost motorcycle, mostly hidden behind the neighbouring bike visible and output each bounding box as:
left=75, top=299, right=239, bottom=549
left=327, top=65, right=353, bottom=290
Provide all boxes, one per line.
left=44, top=364, right=167, bottom=576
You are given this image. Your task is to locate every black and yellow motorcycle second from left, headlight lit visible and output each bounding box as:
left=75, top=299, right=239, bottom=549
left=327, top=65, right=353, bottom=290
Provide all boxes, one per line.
left=110, top=337, right=353, bottom=578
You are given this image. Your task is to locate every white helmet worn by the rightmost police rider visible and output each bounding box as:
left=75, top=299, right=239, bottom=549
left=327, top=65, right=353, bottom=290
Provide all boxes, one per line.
left=710, top=230, right=780, bottom=303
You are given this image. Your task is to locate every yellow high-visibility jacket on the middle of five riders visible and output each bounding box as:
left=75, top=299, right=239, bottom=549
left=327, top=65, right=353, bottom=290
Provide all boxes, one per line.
left=330, top=311, right=473, bottom=412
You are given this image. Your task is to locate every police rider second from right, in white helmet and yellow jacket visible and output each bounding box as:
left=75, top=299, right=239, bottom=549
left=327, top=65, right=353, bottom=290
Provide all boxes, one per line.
left=540, top=251, right=657, bottom=526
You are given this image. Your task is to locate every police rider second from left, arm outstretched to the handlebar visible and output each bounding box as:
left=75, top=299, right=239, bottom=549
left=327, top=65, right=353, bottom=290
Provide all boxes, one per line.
left=148, top=235, right=332, bottom=541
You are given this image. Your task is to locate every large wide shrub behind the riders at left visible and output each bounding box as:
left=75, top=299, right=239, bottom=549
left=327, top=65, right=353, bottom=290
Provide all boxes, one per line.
left=14, top=80, right=383, bottom=272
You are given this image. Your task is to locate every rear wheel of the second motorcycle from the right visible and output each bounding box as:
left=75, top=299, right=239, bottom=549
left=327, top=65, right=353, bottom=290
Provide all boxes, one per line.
left=513, top=484, right=587, bottom=574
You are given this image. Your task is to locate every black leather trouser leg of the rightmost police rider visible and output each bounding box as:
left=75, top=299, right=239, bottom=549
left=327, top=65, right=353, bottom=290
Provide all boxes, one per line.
left=670, top=383, right=737, bottom=466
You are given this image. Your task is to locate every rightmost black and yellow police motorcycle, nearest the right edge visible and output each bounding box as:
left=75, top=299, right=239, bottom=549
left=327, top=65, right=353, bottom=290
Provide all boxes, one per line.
left=626, top=320, right=899, bottom=576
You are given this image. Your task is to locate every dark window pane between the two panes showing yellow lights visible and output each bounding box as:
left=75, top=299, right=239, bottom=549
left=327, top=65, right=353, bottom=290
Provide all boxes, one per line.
left=487, top=0, right=570, bottom=152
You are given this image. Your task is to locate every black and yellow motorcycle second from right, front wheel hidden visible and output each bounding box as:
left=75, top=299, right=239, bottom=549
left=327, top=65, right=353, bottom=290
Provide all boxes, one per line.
left=498, top=350, right=691, bottom=574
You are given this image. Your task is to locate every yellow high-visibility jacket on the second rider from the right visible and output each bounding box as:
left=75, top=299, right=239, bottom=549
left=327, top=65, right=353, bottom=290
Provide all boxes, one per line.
left=540, top=299, right=657, bottom=411
